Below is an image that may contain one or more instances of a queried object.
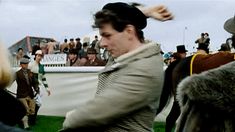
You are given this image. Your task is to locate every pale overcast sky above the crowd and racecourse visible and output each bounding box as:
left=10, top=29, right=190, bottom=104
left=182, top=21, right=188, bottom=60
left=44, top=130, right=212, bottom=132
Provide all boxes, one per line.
left=0, top=0, right=235, bottom=51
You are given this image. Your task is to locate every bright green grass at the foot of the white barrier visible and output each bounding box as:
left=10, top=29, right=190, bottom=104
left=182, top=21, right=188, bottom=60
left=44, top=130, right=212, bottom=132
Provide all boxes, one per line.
left=26, top=115, right=168, bottom=132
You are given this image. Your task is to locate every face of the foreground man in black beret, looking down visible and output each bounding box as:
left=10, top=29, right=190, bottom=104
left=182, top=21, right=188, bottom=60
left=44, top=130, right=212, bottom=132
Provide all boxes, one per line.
left=99, top=24, right=129, bottom=58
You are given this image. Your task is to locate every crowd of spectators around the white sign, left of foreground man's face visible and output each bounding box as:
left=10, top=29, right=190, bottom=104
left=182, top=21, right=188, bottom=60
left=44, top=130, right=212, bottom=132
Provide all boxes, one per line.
left=16, top=35, right=109, bottom=66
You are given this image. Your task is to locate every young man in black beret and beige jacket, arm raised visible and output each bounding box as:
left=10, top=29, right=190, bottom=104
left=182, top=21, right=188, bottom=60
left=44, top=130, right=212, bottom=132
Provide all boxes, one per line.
left=63, top=2, right=173, bottom=132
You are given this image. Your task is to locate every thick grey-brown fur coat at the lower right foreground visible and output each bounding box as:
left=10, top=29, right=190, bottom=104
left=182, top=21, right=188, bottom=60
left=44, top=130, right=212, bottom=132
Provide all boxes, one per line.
left=176, top=62, right=235, bottom=132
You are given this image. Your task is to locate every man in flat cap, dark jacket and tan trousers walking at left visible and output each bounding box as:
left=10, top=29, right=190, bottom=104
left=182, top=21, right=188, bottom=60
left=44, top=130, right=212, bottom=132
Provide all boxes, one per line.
left=16, top=57, right=38, bottom=129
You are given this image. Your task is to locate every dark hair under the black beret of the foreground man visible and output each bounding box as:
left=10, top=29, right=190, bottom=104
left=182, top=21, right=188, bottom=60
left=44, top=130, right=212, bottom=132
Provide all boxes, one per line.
left=92, top=10, right=144, bottom=42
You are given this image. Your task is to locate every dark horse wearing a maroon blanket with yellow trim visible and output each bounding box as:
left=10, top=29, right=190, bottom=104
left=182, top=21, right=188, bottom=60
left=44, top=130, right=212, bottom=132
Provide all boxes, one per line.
left=156, top=51, right=235, bottom=132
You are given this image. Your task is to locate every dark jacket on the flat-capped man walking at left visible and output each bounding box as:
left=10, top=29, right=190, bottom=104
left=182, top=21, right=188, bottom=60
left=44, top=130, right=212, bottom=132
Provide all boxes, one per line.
left=16, top=69, right=36, bottom=98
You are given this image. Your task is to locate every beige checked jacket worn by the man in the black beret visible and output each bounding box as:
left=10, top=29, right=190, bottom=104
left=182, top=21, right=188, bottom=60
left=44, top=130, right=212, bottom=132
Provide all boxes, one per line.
left=63, top=43, right=163, bottom=132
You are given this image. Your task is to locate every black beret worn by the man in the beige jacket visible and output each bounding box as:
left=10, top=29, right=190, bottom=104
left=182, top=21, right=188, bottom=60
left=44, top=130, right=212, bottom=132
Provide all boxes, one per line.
left=102, top=2, right=147, bottom=29
